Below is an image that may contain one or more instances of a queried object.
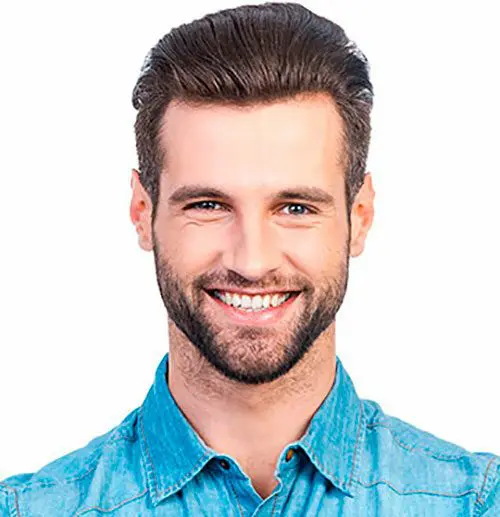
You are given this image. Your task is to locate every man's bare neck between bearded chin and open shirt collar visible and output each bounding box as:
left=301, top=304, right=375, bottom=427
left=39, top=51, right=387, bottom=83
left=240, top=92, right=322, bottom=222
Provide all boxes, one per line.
left=168, top=323, right=335, bottom=494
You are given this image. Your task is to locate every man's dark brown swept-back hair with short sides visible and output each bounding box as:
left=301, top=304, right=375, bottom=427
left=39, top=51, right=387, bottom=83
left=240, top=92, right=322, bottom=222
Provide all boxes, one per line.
left=132, top=3, right=373, bottom=221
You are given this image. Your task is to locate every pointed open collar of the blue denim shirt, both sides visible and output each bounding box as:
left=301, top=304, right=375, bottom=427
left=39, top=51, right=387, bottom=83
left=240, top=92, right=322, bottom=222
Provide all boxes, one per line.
left=138, top=353, right=364, bottom=506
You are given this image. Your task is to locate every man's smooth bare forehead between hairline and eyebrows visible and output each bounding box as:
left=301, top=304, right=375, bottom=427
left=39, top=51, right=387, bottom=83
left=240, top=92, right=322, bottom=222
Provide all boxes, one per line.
left=159, top=94, right=343, bottom=190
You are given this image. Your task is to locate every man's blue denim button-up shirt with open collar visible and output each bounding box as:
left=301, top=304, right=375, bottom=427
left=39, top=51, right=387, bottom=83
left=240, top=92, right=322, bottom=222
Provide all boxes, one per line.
left=0, top=354, right=500, bottom=517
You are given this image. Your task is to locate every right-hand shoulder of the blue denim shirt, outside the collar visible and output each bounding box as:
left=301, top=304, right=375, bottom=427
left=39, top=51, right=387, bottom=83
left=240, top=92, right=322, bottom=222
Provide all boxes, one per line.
left=359, top=400, right=500, bottom=515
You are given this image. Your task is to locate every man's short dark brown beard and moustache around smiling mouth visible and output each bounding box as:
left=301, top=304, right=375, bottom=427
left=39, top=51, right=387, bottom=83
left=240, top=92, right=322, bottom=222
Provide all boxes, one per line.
left=153, top=235, right=349, bottom=385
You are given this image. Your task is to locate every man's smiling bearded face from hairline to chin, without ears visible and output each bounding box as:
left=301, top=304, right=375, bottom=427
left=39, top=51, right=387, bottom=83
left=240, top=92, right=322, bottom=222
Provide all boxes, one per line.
left=135, top=95, right=370, bottom=384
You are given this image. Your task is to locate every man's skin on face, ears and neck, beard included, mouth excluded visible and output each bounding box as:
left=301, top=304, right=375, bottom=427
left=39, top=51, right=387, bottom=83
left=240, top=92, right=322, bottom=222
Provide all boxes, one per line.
left=130, top=90, right=375, bottom=498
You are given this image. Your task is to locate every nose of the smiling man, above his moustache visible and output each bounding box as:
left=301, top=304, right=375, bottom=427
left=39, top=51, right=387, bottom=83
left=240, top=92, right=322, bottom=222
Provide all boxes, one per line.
left=223, top=214, right=280, bottom=281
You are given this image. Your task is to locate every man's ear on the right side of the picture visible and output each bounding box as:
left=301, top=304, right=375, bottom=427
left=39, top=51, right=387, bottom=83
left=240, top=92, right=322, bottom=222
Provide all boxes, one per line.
left=351, top=172, right=375, bottom=257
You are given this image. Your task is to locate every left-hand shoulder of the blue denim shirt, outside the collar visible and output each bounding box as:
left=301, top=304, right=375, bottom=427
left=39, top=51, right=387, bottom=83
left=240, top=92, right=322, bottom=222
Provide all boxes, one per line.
left=0, top=409, right=145, bottom=517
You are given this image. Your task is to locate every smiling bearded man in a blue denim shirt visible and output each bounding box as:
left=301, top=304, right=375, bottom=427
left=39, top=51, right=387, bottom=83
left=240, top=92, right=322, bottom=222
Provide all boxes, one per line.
left=0, top=4, right=500, bottom=517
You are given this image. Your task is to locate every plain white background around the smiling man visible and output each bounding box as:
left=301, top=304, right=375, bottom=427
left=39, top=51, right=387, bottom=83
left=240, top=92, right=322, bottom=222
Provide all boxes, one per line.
left=0, top=0, right=500, bottom=478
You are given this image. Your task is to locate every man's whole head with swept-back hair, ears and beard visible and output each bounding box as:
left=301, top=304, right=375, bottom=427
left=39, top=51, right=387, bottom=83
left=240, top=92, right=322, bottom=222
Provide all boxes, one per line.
left=131, top=4, right=373, bottom=383
